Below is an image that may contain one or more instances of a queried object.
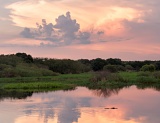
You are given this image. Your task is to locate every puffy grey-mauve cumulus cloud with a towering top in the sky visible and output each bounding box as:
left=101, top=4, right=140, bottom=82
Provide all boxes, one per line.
left=20, top=12, right=104, bottom=46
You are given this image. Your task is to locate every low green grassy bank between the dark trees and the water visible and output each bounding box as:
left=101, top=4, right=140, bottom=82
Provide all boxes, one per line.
left=0, top=72, right=160, bottom=91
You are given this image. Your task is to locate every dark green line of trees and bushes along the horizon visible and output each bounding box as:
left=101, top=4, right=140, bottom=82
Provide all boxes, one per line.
left=0, top=53, right=160, bottom=77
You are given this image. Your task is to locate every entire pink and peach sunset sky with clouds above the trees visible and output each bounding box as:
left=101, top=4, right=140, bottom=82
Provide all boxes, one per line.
left=0, top=0, right=160, bottom=60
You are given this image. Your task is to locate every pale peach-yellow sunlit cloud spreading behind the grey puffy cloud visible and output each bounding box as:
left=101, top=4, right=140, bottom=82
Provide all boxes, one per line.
left=7, top=0, right=148, bottom=29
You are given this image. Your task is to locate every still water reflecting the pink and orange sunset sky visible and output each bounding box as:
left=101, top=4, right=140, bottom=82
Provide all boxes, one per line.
left=0, top=86, right=160, bottom=123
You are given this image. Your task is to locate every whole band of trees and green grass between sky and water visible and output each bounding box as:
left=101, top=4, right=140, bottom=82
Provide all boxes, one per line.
left=0, top=53, right=160, bottom=92
